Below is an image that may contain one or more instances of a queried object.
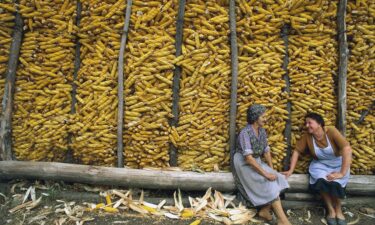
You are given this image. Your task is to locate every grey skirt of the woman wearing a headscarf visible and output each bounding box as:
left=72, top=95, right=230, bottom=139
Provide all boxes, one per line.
left=233, top=153, right=289, bottom=206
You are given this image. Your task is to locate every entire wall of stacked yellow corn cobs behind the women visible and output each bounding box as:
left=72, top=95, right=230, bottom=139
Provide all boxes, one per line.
left=0, top=0, right=375, bottom=174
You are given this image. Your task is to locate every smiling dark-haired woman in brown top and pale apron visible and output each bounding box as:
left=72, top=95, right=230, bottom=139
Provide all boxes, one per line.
left=283, top=113, right=352, bottom=225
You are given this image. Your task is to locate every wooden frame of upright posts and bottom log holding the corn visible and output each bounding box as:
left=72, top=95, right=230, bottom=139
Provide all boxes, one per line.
left=0, top=0, right=375, bottom=194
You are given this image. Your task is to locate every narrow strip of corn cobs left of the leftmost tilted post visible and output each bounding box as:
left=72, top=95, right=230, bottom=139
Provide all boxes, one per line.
left=0, top=1, right=15, bottom=112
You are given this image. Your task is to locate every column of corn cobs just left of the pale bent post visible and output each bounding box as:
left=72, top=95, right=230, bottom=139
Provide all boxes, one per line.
left=70, top=0, right=126, bottom=166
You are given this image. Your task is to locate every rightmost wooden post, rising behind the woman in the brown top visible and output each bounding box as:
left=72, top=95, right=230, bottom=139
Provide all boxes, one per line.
left=337, top=0, right=348, bottom=136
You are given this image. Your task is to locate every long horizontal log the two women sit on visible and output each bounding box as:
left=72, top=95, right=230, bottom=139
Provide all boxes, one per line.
left=0, top=161, right=375, bottom=195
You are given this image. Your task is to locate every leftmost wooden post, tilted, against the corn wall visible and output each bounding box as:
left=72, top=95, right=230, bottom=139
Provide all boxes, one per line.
left=0, top=8, right=23, bottom=160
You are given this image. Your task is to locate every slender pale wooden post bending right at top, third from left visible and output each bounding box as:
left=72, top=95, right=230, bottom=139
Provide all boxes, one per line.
left=117, top=0, right=133, bottom=168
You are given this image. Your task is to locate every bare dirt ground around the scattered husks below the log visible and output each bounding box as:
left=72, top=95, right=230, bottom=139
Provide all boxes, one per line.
left=0, top=181, right=375, bottom=225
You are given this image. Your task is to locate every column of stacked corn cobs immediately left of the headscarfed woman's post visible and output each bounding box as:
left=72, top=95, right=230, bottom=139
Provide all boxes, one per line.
left=176, top=1, right=234, bottom=171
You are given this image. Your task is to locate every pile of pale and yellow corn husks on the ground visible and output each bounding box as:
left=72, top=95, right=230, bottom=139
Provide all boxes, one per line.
left=86, top=188, right=257, bottom=224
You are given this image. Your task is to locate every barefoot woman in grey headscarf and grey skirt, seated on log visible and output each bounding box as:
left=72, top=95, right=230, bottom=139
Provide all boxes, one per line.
left=232, top=104, right=290, bottom=225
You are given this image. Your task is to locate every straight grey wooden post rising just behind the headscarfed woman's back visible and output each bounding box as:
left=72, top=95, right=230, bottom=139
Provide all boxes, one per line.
left=229, top=0, right=238, bottom=158
